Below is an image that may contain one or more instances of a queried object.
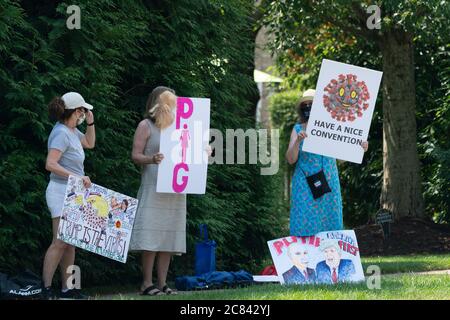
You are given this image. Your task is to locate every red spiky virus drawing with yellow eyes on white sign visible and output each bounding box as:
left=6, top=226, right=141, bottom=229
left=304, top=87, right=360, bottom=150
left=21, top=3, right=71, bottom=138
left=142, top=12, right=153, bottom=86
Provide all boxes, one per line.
left=323, top=74, right=370, bottom=122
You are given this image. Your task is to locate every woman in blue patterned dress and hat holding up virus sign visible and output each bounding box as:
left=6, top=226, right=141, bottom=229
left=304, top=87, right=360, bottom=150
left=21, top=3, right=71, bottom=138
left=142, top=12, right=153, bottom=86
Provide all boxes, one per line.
left=286, top=89, right=368, bottom=236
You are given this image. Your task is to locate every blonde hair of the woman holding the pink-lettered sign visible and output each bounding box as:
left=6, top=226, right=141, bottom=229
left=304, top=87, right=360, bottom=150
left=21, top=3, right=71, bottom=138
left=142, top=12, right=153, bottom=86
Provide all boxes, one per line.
left=146, top=87, right=177, bottom=129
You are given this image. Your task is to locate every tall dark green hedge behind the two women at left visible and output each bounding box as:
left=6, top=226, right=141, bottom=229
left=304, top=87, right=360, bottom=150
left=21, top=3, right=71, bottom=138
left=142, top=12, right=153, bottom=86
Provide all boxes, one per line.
left=0, top=0, right=283, bottom=285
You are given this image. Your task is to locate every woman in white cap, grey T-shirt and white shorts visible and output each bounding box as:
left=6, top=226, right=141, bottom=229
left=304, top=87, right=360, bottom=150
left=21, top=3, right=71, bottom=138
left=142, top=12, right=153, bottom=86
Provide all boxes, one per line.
left=42, top=92, right=95, bottom=299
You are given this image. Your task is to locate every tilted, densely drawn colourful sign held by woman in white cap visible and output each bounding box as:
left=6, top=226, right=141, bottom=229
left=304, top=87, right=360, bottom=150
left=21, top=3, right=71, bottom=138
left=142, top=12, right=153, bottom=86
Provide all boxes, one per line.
left=58, top=176, right=138, bottom=263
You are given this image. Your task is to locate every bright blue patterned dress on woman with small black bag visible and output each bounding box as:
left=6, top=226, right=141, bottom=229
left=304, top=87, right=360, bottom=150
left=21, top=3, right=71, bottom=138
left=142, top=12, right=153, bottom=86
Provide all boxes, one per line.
left=290, top=124, right=343, bottom=236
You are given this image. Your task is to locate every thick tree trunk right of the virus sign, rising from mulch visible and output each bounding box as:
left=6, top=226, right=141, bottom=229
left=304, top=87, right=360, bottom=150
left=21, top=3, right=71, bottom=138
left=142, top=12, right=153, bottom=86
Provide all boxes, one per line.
left=380, top=30, right=424, bottom=220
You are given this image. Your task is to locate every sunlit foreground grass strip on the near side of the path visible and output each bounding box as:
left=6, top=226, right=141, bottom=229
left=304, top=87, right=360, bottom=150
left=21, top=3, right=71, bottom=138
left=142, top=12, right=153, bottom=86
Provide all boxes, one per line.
left=97, top=275, right=450, bottom=300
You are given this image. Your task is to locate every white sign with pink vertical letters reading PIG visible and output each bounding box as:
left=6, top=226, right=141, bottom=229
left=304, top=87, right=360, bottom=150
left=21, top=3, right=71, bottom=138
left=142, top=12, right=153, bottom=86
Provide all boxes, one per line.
left=156, top=97, right=210, bottom=194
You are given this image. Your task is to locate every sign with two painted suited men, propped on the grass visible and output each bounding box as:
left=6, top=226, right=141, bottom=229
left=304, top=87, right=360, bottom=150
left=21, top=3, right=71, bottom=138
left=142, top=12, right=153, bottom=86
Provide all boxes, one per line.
left=267, top=230, right=364, bottom=284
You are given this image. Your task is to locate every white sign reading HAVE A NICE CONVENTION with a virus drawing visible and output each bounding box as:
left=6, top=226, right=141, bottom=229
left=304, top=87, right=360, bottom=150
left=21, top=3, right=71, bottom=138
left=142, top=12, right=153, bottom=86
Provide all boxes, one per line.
left=303, top=59, right=383, bottom=163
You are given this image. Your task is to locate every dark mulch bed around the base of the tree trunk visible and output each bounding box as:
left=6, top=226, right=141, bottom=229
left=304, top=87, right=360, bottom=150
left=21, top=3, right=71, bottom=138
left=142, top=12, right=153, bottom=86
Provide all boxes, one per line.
left=354, top=218, right=450, bottom=256
